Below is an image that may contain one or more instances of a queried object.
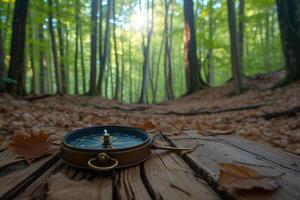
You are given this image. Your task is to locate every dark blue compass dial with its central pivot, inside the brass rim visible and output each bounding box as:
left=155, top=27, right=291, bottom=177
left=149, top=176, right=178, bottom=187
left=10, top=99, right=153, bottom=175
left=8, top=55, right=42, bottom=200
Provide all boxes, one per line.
left=64, top=126, right=150, bottom=150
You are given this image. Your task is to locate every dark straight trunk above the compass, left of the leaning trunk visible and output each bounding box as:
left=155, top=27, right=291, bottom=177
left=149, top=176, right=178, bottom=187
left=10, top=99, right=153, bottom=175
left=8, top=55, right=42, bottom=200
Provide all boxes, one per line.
left=89, top=0, right=98, bottom=96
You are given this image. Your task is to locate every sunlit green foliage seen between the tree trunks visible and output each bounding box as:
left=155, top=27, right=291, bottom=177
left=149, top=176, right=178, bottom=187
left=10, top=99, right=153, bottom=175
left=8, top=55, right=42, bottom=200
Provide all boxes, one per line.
left=0, top=0, right=283, bottom=103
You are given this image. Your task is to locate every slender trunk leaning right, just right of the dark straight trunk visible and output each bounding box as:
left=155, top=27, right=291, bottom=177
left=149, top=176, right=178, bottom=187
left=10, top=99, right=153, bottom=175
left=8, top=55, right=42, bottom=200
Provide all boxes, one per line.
left=98, top=0, right=115, bottom=95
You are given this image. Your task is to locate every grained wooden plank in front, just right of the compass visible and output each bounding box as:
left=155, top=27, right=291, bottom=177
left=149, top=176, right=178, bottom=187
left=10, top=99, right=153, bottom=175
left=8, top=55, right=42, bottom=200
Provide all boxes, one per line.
left=142, top=150, right=219, bottom=200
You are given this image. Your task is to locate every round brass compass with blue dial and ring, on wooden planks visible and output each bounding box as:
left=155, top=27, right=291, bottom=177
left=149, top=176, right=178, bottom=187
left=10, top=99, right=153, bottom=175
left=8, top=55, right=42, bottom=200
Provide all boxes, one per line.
left=61, top=126, right=190, bottom=171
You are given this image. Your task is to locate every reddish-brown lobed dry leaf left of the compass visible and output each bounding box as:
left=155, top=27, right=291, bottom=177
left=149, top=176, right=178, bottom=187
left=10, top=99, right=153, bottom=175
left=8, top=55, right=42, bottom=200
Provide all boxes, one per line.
left=9, top=132, right=55, bottom=163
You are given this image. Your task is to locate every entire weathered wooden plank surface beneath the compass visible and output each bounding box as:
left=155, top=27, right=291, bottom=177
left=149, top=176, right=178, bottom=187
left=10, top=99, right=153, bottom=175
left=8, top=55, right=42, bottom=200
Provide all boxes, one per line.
left=0, top=132, right=300, bottom=200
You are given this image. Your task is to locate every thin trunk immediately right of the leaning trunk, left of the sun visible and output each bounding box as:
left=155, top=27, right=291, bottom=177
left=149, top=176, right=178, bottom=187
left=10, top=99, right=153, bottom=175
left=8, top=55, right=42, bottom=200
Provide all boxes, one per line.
left=113, top=0, right=119, bottom=99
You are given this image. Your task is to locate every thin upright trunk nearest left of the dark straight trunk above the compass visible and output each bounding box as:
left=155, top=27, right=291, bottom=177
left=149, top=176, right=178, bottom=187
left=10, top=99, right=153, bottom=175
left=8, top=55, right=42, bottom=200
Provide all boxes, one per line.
left=74, top=0, right=80, bottom=95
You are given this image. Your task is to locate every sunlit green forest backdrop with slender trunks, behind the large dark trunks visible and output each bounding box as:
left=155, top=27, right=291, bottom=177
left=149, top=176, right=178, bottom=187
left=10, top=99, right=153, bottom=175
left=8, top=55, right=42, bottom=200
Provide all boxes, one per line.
left=0, top=0, right=292, bottom=103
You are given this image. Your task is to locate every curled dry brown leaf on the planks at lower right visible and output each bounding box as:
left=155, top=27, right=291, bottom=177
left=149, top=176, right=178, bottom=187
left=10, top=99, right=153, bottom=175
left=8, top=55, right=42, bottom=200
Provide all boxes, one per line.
left=218, top=163, right=279, bottom=191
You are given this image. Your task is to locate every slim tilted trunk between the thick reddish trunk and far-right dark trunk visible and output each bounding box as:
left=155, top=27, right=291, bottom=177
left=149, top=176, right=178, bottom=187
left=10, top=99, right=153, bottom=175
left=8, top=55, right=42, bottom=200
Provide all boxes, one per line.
left=227, top=0, right=242, bottom=94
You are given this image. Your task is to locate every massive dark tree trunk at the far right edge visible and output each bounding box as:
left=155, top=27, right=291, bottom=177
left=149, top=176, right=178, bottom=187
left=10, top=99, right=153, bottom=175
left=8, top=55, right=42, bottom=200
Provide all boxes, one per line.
left=276, top=0, right=300, bottom=85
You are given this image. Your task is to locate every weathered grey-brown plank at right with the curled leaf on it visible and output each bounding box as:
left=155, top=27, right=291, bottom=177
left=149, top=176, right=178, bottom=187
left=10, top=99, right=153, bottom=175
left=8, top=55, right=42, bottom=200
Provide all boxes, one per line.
left=167, top=132, right=300, bottom=200
